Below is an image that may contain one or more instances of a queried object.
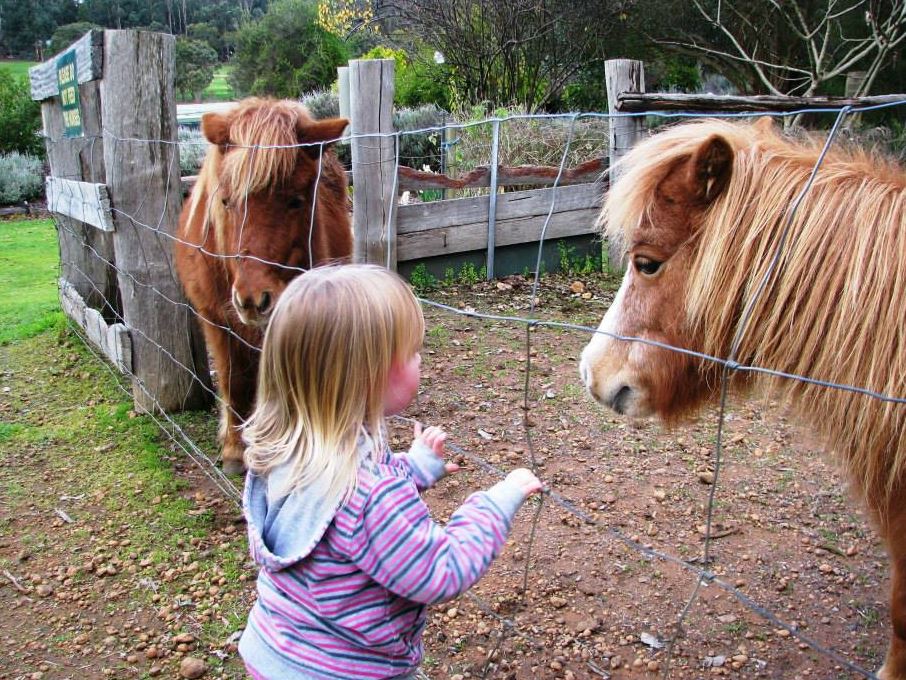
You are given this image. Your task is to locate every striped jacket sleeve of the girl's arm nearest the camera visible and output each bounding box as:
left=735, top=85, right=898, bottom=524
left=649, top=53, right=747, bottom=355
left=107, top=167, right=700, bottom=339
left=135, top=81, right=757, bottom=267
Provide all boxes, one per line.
left=349, top=477, right=524, bottom=604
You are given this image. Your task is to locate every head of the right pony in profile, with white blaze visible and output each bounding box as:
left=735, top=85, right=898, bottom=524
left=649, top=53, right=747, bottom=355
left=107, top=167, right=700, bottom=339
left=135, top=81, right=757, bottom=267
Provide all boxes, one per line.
left=580, top=121, right=772, bottom=420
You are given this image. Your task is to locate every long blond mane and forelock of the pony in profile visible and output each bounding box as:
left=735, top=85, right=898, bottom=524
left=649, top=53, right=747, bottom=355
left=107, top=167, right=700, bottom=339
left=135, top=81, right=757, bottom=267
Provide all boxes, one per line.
left=603, top=120, right=906, bottom=507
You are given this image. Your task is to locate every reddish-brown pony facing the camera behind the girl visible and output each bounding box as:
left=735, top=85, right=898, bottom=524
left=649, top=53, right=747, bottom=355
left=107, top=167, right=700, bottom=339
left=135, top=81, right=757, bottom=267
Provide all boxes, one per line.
left=175, top=98, right=352, bottom=472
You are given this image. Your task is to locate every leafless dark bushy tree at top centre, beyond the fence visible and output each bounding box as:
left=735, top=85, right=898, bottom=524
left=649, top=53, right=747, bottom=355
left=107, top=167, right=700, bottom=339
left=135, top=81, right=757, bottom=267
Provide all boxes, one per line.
left=380, top=0, right=634, bottom=111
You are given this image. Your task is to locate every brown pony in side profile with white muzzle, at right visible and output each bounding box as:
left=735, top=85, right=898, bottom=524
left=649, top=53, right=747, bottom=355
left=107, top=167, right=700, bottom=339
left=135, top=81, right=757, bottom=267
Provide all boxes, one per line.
left=580, top=119, right=906, bottom=680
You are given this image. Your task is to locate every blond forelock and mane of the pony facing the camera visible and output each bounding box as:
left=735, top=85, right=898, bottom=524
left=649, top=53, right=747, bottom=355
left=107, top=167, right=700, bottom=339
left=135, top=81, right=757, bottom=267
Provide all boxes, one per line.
left=183, top=97, right=311, bottom=248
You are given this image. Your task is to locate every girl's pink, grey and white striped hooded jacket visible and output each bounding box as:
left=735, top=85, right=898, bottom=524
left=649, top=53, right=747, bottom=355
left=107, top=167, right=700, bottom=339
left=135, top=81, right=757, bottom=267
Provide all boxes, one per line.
left=239, top=438, right=524, bottom=680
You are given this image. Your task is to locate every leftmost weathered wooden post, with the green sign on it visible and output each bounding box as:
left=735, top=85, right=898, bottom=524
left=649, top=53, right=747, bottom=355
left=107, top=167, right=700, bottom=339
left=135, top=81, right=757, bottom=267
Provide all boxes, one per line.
left=29, top=30, right=122, bottom=322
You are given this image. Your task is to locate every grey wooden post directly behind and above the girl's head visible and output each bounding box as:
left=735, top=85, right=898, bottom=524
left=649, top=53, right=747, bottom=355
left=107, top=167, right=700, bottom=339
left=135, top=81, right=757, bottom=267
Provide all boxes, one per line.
left=349, top=59, right=397, bottom=270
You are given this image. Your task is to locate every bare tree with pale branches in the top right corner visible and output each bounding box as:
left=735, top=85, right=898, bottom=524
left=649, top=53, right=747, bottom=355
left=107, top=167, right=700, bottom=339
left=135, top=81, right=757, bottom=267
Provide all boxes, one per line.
left=655, top=0, right=906, bottom=96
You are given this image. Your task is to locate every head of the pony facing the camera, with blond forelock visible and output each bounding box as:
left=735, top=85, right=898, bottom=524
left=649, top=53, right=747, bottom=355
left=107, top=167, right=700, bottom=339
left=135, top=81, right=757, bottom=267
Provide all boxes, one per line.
left=190, top=98, right=348, bottom=325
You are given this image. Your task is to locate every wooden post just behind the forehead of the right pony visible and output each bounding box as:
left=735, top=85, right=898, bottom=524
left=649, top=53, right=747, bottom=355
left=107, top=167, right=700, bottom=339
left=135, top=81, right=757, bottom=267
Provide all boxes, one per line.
left=604, top=59, right=645, bottom=271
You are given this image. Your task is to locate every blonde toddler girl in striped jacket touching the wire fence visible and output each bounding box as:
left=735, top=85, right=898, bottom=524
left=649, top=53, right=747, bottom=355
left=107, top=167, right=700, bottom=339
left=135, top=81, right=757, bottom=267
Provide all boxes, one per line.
left=239, top=265, right=541, bottom=680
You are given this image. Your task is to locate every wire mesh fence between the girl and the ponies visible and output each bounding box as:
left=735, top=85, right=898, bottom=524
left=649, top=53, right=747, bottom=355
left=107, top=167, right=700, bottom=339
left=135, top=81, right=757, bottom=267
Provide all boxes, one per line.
left=48, top=101, right=906, bottom=678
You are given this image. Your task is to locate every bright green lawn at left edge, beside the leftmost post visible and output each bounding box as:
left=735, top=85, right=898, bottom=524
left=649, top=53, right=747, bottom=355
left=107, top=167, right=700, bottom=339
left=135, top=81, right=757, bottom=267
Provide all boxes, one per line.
left=0, top=220, right=63, bottom=345
